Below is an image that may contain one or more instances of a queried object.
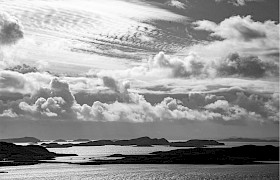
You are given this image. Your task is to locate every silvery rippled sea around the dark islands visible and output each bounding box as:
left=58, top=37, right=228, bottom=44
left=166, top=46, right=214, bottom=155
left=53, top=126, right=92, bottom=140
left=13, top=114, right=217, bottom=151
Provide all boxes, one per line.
left=0, top=142, right=279, bottom=180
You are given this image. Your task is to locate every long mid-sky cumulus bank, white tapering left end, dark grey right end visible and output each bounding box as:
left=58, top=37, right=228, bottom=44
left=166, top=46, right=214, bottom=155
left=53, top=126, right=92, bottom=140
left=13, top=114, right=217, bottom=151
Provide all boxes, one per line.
left=92, top=52, right=279, bottom=79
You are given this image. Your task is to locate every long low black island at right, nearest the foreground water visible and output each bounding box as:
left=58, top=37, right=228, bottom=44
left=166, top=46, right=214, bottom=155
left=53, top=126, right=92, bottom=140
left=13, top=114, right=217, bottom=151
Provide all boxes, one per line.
left=79, top=145, right=279, bottom=165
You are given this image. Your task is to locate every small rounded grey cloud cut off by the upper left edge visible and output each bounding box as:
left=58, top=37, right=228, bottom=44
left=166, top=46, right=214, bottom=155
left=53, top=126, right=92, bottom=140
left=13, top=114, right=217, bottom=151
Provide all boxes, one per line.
left=0, top=13, right=24, bottom=45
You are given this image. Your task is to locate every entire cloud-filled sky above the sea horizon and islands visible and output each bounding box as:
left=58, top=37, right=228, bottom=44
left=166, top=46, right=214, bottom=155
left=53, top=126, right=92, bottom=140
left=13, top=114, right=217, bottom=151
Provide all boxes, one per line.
left=0, top=0, right=279, bottom=140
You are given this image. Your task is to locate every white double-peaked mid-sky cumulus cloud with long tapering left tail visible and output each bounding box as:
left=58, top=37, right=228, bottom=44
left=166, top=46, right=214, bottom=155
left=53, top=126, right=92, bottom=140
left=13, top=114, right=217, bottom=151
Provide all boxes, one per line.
left=93, top=52, right=212, bottom=80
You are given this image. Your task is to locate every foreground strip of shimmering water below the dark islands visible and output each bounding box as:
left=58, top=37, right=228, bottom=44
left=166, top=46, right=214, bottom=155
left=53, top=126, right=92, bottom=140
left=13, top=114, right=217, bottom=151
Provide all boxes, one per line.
left=0, top=164, right=279, bottom=180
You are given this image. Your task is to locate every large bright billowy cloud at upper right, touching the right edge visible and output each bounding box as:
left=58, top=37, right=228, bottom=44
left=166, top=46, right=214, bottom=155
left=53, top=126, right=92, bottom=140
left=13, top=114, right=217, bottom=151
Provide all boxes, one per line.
left=190, top=15, right=279, bottom=59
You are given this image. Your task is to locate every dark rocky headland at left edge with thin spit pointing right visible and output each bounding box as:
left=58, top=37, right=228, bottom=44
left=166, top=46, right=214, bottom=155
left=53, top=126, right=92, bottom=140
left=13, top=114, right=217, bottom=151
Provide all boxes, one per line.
left=0, top=142, right=77, bottom=166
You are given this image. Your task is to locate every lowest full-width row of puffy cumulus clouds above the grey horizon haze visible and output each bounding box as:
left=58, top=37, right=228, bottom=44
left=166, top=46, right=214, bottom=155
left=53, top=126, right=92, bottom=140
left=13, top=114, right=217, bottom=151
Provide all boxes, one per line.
left=0, top=74, right=279, bottom=124
